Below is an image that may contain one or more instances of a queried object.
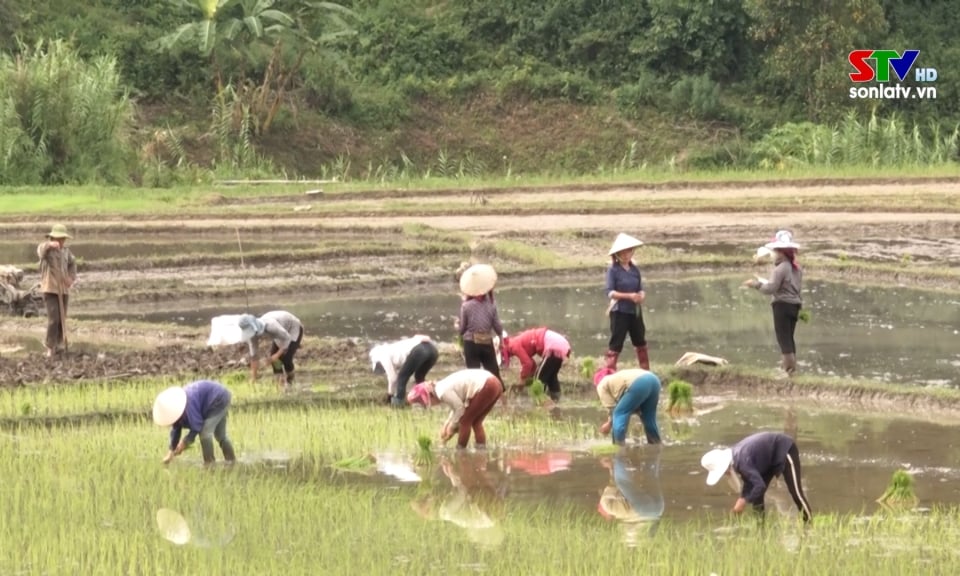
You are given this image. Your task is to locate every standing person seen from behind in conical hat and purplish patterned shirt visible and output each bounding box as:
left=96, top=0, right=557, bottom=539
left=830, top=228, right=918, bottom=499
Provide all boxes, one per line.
left=458, top=264, right=503, bottom=379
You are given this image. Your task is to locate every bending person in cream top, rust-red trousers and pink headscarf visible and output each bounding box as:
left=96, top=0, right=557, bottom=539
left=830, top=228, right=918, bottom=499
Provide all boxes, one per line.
left=407, top=368, right=503, bottom=450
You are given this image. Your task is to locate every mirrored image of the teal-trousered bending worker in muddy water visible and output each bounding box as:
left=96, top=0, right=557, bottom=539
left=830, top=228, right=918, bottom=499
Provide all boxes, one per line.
left=597, top=445, right=665, bottom=546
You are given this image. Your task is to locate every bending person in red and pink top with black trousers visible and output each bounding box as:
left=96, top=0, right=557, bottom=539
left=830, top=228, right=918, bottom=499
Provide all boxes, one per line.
left=502, top=327, right=570, bottom=402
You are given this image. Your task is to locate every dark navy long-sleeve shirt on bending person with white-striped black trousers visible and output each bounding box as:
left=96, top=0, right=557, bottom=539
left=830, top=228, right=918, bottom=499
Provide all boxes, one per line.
left=732, top=432, right=794, bottom=505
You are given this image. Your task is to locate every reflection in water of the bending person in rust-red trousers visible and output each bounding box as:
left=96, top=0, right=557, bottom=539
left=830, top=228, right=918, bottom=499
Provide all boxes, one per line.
left=411, top=452, right=507, bottom=548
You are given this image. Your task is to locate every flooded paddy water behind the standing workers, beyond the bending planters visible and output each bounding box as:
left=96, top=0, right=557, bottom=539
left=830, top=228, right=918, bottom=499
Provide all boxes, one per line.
left=92, top=279, right=960, bottom=385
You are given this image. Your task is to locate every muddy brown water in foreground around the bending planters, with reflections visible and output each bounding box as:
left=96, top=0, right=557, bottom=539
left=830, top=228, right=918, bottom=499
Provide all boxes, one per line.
left=281, top=399, right=960, bottom=521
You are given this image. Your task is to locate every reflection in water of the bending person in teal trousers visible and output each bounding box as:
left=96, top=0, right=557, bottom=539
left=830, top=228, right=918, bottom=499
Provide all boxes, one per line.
left=597, top=446, right=664, bottom=534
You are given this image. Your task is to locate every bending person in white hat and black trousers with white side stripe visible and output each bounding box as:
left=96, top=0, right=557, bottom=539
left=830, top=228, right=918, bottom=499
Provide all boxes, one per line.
left=700, top=432, right=813, bottom=522
